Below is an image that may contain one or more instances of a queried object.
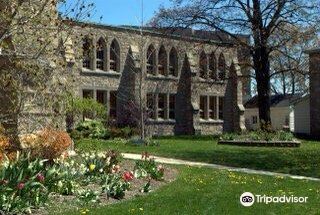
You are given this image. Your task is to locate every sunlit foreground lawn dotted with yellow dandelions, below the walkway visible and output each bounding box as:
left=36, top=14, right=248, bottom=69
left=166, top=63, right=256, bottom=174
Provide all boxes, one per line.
left=59, top=166, right=320, bottom=215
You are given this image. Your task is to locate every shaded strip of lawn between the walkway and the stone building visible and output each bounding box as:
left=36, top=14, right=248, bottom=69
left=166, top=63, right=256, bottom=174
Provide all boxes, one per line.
left=76, top=137, right=320, bottom=178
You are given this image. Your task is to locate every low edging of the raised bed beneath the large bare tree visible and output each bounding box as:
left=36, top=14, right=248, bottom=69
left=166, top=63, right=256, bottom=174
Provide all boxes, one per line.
left=218, top=140, right=301, bottom=147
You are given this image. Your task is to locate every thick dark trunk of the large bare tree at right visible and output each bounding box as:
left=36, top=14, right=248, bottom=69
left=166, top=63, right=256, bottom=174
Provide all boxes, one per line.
left=253, top=46, right=271, bottom=131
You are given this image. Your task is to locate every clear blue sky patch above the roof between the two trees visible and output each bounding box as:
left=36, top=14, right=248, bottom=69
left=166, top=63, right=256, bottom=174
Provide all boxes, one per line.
left=62, top=0, right=170, bottom=25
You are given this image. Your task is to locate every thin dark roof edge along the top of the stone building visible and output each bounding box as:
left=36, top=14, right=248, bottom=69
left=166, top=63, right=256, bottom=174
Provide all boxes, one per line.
left=62, top=19, right=238, bottom=46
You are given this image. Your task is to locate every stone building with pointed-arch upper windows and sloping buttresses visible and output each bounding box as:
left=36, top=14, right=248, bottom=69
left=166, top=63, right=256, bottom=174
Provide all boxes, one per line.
left=65, top=23, right=250, bottom=135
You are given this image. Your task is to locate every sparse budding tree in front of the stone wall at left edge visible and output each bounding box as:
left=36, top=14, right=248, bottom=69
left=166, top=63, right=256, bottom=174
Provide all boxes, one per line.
left=0, top=0, right=94, bottom=149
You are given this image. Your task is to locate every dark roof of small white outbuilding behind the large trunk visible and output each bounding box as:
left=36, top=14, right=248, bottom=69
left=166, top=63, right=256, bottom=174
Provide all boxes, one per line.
left=244, top=94, right=302, bottom=109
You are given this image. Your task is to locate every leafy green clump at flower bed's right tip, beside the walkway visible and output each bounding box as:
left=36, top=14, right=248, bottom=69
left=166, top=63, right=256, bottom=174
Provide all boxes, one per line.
left=134, top=153, right=164, bottom=180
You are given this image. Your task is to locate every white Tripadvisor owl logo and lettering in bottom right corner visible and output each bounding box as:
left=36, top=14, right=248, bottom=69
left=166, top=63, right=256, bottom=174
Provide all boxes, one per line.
left=240, top=192, right=308, bottom=207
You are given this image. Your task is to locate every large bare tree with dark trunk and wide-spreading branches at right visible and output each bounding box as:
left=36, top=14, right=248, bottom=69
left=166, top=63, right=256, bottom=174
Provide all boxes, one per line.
left=151, top=0, right=320, bottom=129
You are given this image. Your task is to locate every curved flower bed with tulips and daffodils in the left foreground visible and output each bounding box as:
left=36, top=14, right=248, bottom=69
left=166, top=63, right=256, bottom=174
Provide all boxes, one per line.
left=0, top=151, right=176, bottom=214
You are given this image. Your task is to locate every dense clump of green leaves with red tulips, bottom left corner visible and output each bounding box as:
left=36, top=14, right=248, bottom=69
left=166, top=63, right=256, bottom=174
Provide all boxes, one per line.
left=0, top=153, right=49, bottom=213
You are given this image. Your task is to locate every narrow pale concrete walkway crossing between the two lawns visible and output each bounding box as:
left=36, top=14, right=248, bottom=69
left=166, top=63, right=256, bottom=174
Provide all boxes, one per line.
left=122, top=153, right=320, bottom=181
